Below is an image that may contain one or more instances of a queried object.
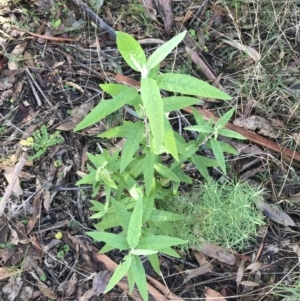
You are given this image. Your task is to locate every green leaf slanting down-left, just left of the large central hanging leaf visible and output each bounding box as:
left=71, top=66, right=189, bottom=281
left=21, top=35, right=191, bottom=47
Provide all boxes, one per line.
left=120, top=121, right=145, bottom=173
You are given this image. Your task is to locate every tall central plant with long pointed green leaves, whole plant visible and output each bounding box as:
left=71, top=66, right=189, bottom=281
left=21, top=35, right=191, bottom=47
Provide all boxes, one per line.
left=75, top=32, right=248, bottom=300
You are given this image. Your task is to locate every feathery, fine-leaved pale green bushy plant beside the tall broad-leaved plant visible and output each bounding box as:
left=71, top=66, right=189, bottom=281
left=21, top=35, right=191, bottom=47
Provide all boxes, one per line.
left=169, top=180, right=264, bottom=249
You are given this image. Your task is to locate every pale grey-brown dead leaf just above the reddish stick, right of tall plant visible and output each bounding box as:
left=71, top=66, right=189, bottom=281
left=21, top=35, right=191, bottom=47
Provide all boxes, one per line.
left=233, top=115, right=280, bottom=138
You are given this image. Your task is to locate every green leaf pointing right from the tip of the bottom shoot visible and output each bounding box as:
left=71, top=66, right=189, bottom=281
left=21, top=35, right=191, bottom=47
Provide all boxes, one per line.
left=137, top=235, right=187, bottom=251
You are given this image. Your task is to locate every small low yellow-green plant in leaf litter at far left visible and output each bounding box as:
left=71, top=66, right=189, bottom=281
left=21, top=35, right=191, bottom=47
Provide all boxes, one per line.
left=20, top=125, right=63, bottom=161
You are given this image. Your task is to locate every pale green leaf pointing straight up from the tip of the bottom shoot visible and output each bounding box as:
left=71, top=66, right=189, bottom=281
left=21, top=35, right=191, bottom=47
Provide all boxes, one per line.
left=127, top=198, right=143, bottom=249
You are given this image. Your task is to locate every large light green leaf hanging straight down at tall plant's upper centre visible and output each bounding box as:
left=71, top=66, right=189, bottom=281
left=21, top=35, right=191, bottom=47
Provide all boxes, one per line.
left=141, top=78, right=164, bottom=152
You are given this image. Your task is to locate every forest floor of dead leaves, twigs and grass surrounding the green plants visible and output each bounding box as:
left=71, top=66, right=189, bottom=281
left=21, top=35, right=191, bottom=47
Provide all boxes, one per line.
left=0, top=0, right=300, bottom=301
